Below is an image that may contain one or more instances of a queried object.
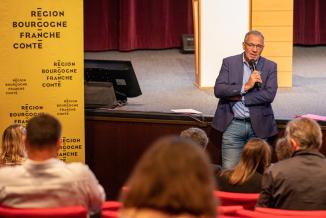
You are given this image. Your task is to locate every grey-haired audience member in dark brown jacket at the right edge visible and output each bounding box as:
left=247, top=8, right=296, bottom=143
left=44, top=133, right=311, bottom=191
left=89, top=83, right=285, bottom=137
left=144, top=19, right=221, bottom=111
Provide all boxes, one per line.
left=257, top=118, right=326, bottom=210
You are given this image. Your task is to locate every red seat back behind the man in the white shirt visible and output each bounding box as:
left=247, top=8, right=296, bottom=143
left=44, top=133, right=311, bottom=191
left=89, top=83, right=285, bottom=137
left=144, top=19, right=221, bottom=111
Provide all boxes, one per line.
left=0, top=206, right=88, bottom=218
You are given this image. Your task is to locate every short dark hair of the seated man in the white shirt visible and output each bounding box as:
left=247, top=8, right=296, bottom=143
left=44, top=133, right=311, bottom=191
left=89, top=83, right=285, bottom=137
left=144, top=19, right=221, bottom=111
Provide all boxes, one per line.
left=26, top=114, right=61, bottom=147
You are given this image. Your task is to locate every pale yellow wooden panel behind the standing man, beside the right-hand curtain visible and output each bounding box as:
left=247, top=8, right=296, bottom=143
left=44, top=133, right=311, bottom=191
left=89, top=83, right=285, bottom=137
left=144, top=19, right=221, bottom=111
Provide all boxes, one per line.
left=251, top=0, right=293, bottom=87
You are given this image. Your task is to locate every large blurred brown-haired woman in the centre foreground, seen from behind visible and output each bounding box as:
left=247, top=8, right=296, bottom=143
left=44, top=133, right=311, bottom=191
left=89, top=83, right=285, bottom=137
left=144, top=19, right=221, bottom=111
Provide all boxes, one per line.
left=120, top=137, right=216, bottom=218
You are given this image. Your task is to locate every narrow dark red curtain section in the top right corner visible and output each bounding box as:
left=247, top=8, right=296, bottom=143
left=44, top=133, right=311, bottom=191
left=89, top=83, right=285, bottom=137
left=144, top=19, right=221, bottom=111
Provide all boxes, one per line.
left=293, top=0, right=326, bottom=45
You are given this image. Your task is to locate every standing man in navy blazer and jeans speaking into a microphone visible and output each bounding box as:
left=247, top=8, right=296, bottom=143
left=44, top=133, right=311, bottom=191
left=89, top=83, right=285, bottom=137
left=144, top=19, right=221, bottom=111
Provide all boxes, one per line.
left=212, top=30, right=277, bottom=169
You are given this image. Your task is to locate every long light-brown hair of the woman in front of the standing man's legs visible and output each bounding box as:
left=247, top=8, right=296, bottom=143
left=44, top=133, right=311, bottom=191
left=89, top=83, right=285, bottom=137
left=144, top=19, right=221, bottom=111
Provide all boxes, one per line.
left=229, top=138, right=271, bottom=184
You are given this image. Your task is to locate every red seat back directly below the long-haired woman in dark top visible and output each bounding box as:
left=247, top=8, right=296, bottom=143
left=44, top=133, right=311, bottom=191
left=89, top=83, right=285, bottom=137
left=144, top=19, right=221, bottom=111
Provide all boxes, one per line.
left=214, top=191, right=259, bottom=210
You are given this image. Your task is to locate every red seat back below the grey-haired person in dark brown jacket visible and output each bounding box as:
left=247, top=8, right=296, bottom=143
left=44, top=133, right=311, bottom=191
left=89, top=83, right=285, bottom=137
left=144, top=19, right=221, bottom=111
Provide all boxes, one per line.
left=255, top=207, right=326, bottom=218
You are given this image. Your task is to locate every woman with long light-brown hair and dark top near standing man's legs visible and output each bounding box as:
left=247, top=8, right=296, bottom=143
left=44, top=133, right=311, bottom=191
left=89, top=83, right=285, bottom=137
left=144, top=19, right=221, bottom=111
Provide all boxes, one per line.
left=217, top=139, right=271, bottom=193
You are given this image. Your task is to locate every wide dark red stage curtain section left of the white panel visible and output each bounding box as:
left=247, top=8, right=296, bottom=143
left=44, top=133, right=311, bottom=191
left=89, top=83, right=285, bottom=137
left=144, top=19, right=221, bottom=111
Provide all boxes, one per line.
left=84, top=0, right=193, bottom=51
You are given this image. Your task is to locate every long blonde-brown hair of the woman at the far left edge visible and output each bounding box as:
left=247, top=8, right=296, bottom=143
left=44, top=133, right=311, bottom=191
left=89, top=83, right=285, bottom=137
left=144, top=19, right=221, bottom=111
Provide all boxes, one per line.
left=0, top=124, right=26, bottom=166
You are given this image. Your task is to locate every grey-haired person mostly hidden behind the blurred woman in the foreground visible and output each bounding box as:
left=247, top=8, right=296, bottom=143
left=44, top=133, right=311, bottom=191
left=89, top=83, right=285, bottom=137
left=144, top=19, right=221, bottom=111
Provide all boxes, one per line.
left=180, top=127, right=222, bottom=176
